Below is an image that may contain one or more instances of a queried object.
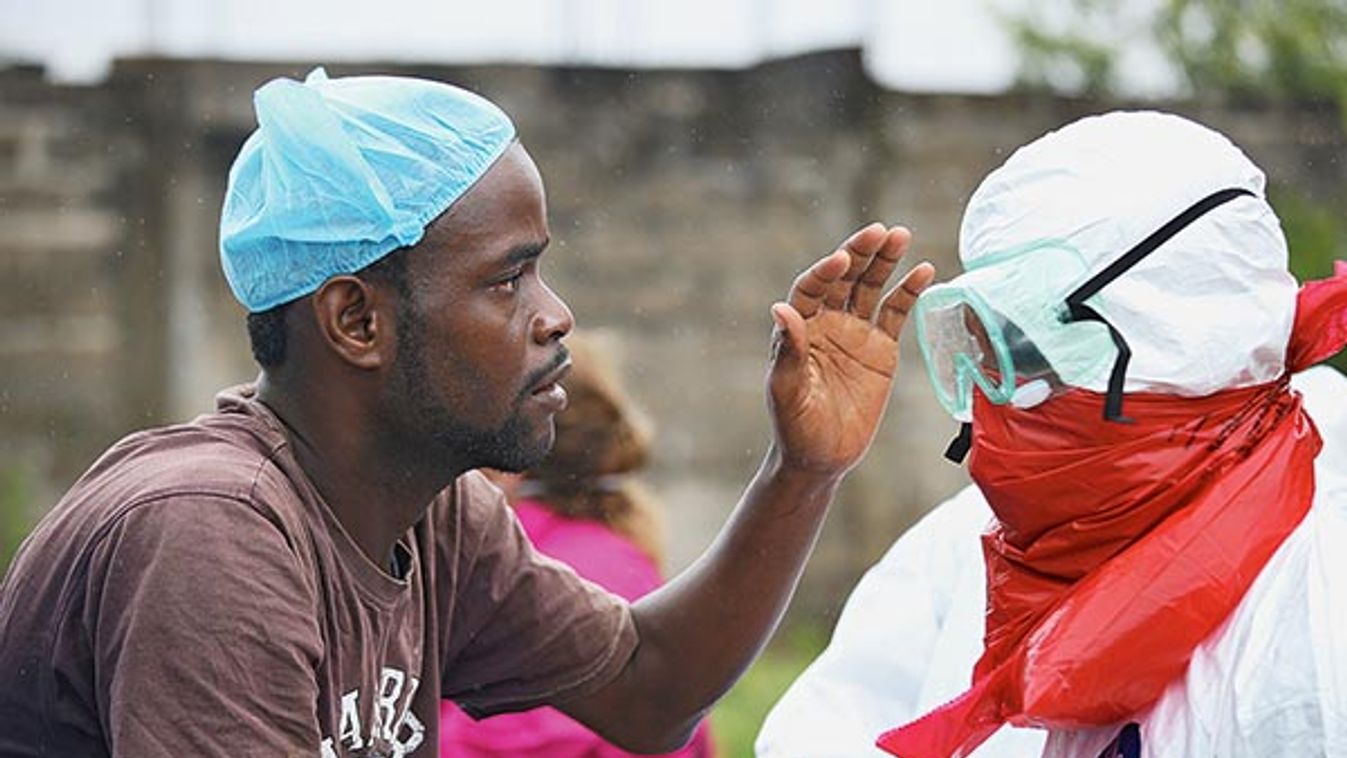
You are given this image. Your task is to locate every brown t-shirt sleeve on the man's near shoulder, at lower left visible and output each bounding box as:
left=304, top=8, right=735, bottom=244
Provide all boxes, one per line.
left=85, top=495, right=322, bottom=758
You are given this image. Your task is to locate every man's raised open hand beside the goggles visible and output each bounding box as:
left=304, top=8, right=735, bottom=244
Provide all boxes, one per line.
left=768, top=223, right=935, bottom=475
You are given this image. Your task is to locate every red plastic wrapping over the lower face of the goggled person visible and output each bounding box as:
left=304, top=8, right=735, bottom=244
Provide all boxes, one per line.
left=878, top=264, right=1347, bottom=758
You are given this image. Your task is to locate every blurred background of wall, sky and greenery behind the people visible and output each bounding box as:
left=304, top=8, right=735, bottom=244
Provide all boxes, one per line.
left=0, top=0, right=1347, bottom=755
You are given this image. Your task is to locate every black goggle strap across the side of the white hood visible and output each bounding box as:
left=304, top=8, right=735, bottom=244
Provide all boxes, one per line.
left=1061, top=187, right=1254, bottom=420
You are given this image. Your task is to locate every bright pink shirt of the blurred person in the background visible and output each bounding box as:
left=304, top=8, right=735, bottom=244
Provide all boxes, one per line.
left=439, top=499, right=713, bottom=758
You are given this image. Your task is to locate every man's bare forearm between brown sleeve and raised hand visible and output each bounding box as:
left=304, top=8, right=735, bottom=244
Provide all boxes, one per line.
left=568, top=448, right=841, bottom=750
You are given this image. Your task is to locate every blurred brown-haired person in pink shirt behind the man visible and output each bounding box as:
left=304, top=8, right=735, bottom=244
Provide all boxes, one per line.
left=439, top=335, right=715, bottom=758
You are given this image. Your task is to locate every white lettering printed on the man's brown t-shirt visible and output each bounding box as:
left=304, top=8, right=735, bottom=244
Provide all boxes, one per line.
left=319, top=666, right=426, bottom=758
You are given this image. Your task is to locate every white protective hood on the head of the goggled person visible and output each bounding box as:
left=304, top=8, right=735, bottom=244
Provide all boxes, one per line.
left=959, top=112, right=1296, bottom=396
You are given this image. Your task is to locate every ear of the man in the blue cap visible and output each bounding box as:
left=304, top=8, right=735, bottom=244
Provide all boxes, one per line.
left=310, top=276, right=396, bottom=369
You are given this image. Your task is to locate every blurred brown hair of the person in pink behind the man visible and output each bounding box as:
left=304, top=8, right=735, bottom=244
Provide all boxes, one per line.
left=519, top=335, right=664, bottom=565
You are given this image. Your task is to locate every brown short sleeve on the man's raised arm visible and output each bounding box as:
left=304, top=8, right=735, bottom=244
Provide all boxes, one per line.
left=438, top=474, right=637, bottom=718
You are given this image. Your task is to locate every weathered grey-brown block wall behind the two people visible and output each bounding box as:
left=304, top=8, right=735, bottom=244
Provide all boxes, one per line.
left=0, top=53, right=1347, bottom=615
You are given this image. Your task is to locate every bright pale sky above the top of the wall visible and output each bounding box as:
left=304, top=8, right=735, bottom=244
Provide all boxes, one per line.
left=0, top=0, right=1174, bottom=93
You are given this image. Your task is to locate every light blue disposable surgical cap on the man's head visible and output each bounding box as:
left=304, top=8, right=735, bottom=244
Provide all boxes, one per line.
left=220, top=69, right=515, bottom=312
